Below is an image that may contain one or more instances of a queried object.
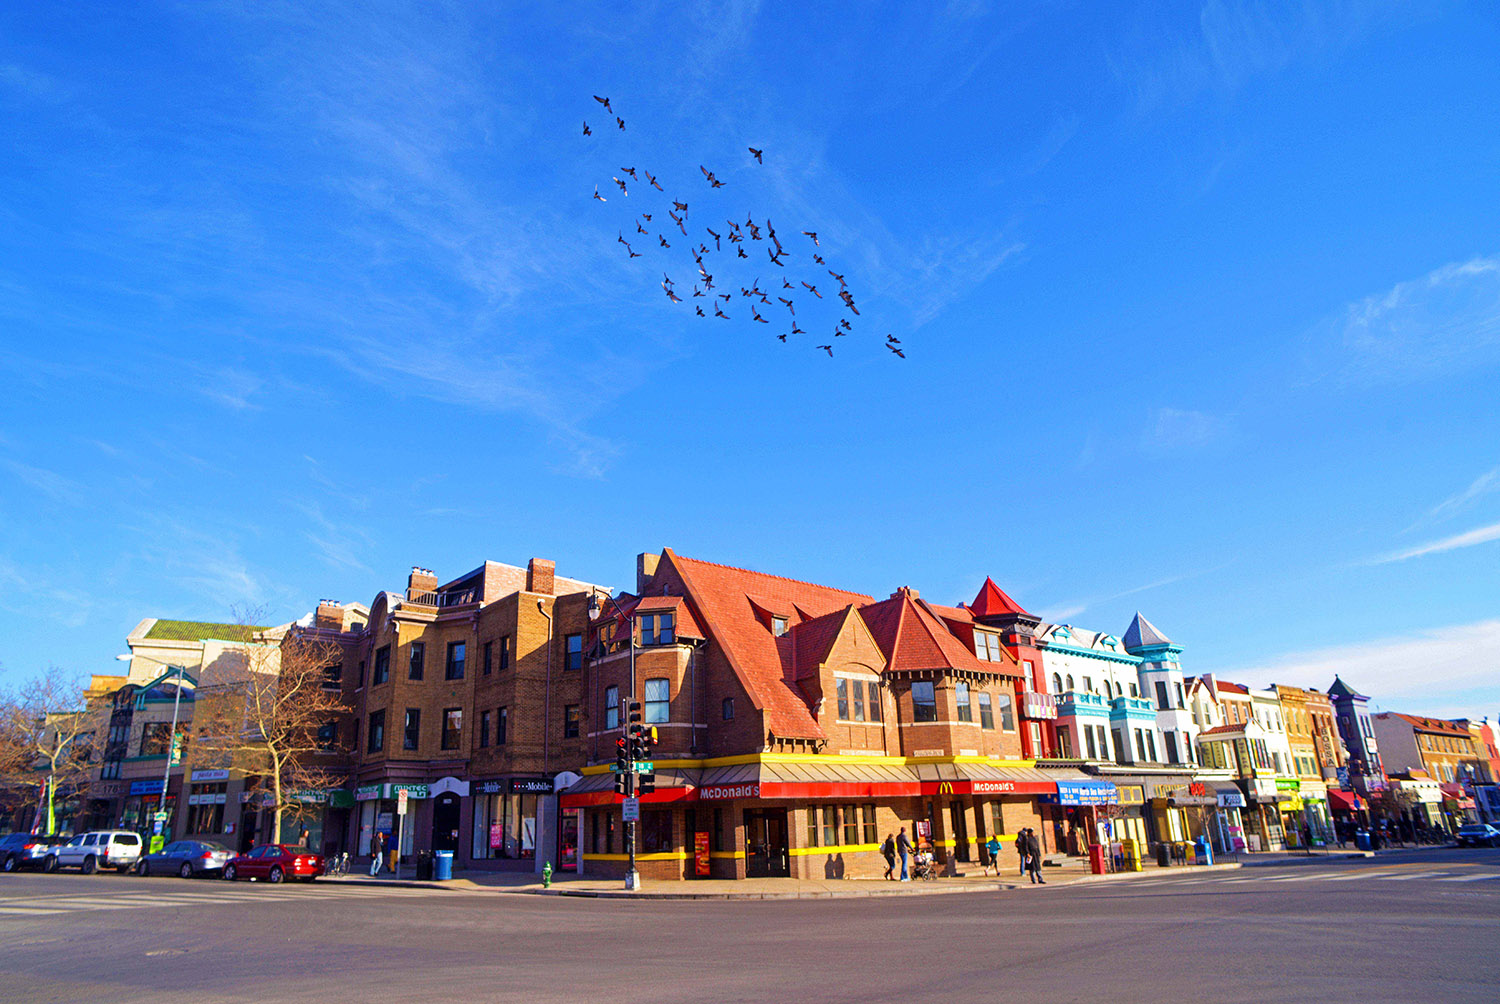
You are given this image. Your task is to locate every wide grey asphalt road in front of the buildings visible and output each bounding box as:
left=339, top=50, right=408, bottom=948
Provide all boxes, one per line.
left=0, top=849, right=1500, bottom=1004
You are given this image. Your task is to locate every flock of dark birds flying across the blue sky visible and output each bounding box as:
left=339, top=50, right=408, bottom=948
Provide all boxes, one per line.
left=584, top=95, right=906, bottom=359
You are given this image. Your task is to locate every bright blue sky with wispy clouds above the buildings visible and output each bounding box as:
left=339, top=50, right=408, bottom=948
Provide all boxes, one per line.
left=0, top=2, right=1500, bottom=717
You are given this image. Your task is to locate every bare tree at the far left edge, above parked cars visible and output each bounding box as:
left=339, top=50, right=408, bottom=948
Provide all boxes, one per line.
left=0, top=666, right=108, bottom=833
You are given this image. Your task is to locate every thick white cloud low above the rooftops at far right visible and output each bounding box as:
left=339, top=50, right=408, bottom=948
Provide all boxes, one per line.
left=1217, top=620, right=1500, bottom=717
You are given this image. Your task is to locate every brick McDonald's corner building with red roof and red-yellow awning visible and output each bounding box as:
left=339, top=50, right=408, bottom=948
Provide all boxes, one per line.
left=563, top=549, right=1083, bottom=878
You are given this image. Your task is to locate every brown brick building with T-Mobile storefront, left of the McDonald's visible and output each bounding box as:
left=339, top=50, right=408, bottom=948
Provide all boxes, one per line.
left=328, top=558, right=605, bottom=870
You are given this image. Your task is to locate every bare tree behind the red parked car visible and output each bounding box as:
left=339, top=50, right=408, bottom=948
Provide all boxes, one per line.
left=188, top=626, right=348, bottom=843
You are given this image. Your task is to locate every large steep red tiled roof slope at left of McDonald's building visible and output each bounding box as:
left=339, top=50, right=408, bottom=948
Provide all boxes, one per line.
left=662, top=548, right=872, bottom=738
